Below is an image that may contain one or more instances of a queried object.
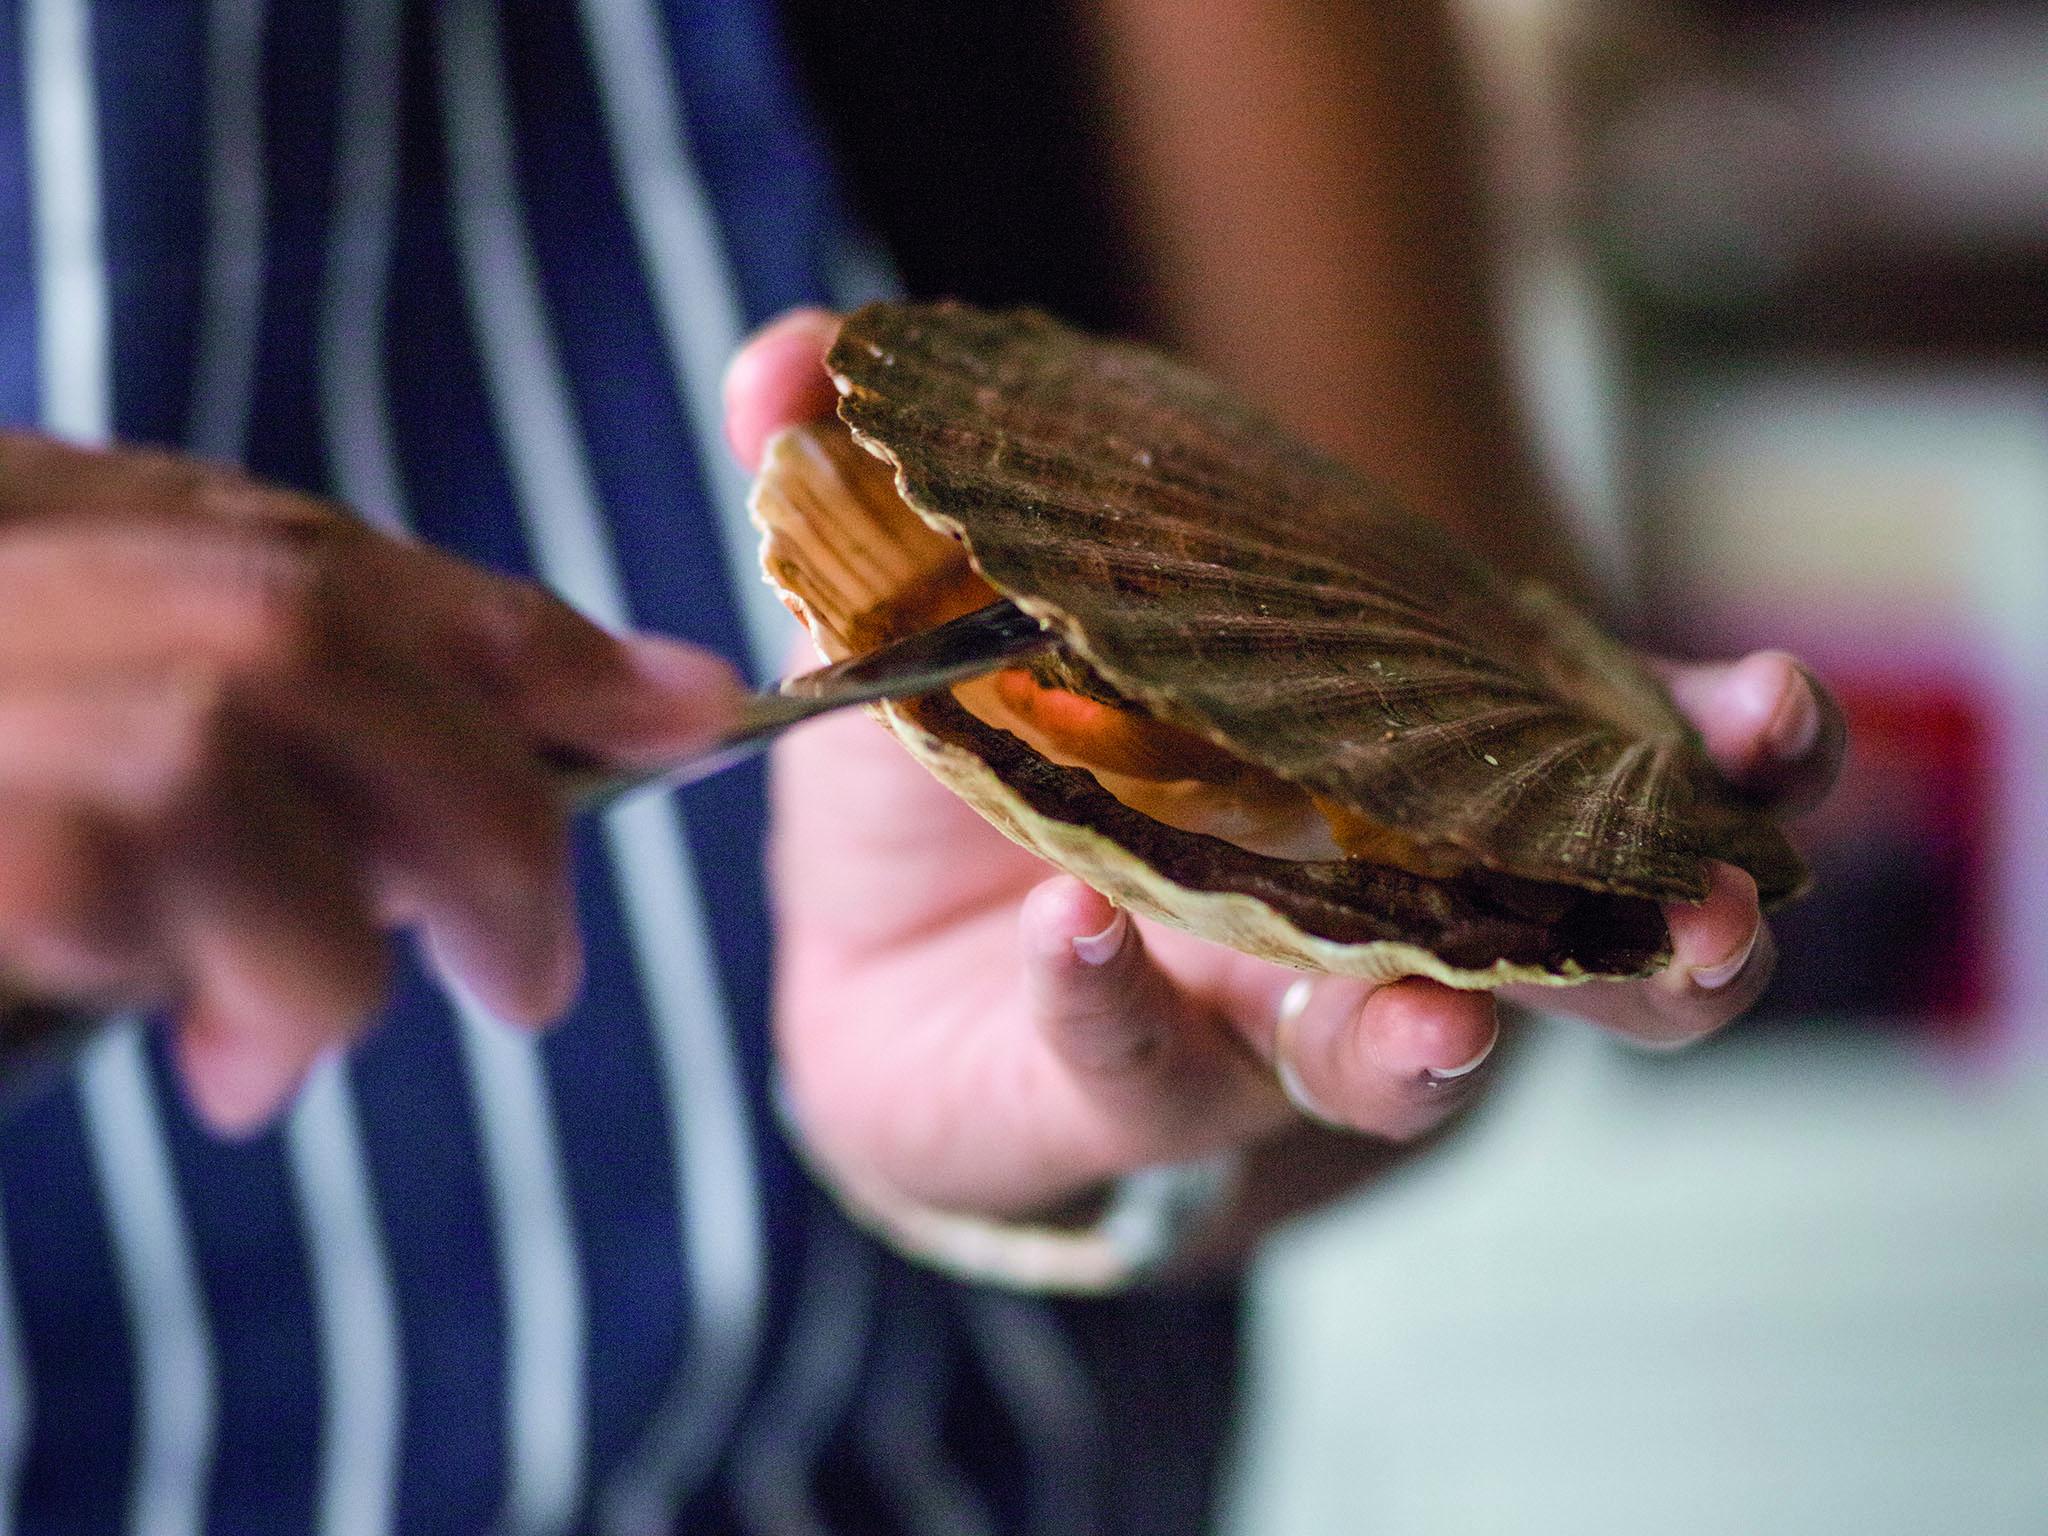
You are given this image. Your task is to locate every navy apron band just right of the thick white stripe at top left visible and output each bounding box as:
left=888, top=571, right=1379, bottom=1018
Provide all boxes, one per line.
left=92, top=6, right=207, bottom=442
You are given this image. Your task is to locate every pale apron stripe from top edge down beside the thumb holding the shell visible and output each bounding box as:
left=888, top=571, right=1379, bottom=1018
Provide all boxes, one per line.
left=580, top=0, right=795, bottom=678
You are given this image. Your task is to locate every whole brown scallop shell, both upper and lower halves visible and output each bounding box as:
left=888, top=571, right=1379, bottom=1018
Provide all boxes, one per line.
left=756, top=305, right=1804, bottom=987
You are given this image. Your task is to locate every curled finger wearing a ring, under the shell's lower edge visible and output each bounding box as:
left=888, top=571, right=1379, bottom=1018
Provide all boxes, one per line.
left=1274, top=977, right=1499, bottom=1141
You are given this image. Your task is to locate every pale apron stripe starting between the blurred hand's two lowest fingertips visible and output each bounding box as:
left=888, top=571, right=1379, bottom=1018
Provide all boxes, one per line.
left=285, top=1059, right=399, bottom=1536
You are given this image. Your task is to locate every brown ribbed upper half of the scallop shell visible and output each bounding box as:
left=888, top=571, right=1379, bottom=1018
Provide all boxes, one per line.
left=827, top=305, right=1804, bottom=903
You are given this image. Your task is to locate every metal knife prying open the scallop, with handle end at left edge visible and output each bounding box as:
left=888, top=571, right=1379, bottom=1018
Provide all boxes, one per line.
left=0, top=600, right=1059, bottom=1110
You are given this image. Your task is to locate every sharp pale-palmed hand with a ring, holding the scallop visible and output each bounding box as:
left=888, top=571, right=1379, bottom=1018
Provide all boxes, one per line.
left=727, top=311, right=1841, bottom=1253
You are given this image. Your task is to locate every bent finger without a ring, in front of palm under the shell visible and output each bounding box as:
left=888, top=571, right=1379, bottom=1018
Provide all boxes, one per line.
left=1018, top=877, right=1288, bottom=1174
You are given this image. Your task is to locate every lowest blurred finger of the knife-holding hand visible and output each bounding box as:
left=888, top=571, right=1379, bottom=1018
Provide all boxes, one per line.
left=162, top=766, right=389, bottom=1135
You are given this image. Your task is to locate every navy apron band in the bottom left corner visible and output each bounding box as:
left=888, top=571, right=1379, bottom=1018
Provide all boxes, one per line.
left=0, top=1085, right=135, bottom=1536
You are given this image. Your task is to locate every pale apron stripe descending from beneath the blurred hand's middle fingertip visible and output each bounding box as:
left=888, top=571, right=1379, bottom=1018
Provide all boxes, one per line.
left=455, top=1011, right=588, bottom=1536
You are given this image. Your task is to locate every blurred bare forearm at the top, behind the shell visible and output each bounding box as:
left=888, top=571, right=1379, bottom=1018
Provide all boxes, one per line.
left=1094, top=0, right=1579, bottom=584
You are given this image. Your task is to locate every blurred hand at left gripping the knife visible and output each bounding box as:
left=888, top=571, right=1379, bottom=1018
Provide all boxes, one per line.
left=0, top=432, right=739, bottom=1130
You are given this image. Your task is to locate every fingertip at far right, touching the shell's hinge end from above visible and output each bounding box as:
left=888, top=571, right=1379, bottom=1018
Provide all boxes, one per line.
left=1659, top=651, right=1847, bottom=813
